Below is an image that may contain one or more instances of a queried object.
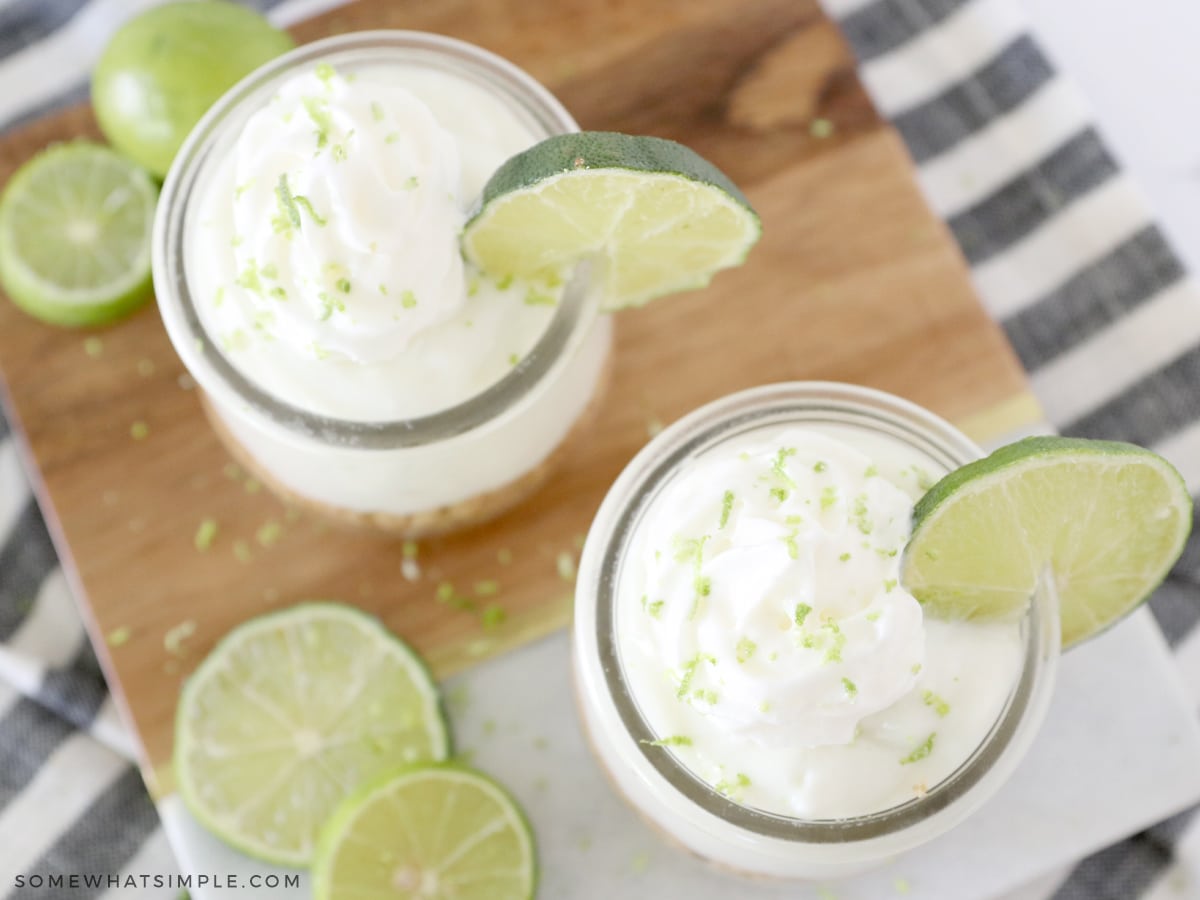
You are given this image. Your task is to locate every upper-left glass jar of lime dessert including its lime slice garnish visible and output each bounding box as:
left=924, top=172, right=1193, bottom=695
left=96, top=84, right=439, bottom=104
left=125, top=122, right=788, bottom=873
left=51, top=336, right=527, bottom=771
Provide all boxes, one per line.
left=154, top=31, right=760, bottom=536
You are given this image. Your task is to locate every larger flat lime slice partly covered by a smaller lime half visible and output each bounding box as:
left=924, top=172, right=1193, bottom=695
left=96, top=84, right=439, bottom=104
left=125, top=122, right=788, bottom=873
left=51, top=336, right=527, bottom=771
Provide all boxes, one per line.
left=174, top=604, right=450, bottom=865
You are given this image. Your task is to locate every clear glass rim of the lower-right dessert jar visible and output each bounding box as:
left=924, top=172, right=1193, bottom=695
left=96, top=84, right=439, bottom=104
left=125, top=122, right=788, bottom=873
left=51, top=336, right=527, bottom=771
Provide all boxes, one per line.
left=576, top=382, right=1060, bottom=845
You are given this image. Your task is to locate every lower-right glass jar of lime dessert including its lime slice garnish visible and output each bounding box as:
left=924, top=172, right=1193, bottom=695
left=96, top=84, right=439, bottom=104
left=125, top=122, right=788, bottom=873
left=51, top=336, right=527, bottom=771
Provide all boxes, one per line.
left=574, top=383, right=1192, bottom=878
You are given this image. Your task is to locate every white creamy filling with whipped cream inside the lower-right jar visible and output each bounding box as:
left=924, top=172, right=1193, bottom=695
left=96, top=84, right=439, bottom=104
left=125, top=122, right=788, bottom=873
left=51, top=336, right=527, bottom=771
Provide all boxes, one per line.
left=618, top=426, right=1021, bottom=818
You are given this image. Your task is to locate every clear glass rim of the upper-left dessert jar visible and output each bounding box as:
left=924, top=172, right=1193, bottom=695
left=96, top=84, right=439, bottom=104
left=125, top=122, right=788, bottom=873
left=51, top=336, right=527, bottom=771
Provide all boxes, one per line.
left=151, top=30, right=599, bottom=450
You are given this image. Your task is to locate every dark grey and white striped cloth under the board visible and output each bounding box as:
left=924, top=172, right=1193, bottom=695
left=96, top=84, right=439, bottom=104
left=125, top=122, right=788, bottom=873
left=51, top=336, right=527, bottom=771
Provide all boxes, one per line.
left=0, top=0, right=1200, bottom=900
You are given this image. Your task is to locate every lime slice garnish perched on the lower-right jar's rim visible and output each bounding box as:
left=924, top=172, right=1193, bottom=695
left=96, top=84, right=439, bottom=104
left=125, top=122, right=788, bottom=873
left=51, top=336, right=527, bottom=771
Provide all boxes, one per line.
left=901, top=437, right=1192, bottom=647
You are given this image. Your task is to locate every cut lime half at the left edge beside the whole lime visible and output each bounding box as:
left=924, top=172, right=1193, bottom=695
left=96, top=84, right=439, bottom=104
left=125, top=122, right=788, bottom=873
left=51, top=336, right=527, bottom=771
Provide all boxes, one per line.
left=0, top=146, right=158, bottom=325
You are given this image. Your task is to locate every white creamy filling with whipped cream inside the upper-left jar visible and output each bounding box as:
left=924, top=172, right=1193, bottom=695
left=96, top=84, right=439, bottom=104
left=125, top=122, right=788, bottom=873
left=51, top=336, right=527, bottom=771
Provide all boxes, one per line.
left=185, top=64, right=562, bottom=420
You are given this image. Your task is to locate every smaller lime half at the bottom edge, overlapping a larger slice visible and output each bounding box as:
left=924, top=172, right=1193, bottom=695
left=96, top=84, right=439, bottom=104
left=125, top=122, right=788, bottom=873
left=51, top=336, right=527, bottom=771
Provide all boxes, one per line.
left=312, top=764, right=538, bottom=900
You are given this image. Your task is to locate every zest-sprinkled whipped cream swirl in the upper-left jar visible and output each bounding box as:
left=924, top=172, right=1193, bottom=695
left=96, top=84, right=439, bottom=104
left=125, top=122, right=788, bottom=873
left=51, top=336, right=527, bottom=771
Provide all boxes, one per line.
left=224, top=64, right=464, bottom=362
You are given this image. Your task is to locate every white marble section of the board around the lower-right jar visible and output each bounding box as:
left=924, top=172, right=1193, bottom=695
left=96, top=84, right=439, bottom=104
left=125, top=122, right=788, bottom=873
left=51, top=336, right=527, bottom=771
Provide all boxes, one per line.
left=161, top=611, right=1200, bottom=900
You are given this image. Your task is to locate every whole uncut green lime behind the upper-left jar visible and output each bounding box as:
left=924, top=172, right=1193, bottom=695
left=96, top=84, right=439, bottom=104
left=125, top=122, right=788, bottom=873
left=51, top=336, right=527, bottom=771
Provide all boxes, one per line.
left=91, top=0, right=295, bottom=178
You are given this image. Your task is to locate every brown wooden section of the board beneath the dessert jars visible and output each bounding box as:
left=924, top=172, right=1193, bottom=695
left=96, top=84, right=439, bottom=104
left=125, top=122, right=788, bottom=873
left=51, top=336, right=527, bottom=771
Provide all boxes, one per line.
left=0, top=0, right=1038, bottom=794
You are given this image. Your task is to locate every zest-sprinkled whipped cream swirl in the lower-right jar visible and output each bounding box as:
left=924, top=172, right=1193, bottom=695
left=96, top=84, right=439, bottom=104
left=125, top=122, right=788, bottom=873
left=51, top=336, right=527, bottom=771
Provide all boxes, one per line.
left=631, top=427, right=925, bottom=746
